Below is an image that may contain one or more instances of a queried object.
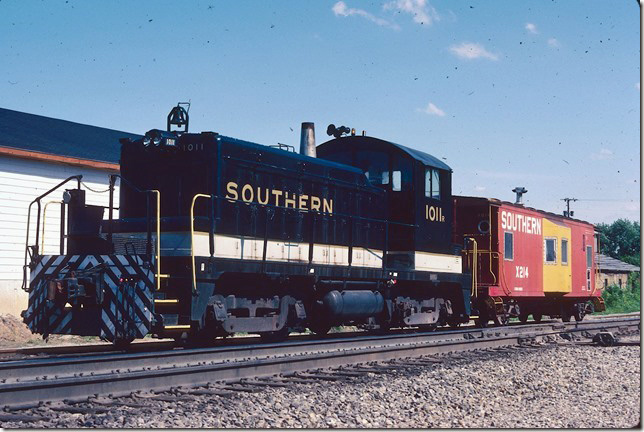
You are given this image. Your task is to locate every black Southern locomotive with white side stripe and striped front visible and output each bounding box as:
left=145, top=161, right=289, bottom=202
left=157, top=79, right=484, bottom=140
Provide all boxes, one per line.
left=23, top=105, right=471, bottom=342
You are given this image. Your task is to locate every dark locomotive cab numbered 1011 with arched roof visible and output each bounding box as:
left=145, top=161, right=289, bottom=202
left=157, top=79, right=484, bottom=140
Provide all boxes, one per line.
left=317, top=136, right=460, bottom=271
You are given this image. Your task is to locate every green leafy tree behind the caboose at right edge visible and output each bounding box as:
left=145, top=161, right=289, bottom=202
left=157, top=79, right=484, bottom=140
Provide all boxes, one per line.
left=597, top=219, right=640, bottom=266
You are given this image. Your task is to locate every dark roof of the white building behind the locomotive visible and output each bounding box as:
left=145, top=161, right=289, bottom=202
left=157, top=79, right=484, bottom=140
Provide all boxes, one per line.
left=0, top=108, right=141, bottom=166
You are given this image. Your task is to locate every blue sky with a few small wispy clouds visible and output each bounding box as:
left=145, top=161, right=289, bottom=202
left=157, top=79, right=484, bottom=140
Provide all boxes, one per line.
left=0, top=0, right=641, bottom=223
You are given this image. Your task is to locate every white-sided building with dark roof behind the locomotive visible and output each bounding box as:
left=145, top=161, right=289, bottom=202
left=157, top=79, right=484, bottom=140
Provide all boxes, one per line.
left=0, top=108, right=139, bottom=315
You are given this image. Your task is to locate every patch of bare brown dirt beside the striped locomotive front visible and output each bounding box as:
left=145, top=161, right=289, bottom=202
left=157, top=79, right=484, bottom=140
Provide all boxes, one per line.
left=0, top=314, right=101, bottom=349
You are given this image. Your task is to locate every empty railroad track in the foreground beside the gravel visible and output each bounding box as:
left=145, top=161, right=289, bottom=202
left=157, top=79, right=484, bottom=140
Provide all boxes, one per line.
left=0, top=315, right=640, bottom=411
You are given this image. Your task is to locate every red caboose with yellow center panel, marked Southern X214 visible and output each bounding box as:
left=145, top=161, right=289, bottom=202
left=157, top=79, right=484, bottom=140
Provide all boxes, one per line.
left=454, top=196, right=605, bottom=326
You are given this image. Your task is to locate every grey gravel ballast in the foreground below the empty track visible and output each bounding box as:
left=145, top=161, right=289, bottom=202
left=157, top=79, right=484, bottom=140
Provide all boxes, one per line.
left=2, top=336, right=641, bottom=428
